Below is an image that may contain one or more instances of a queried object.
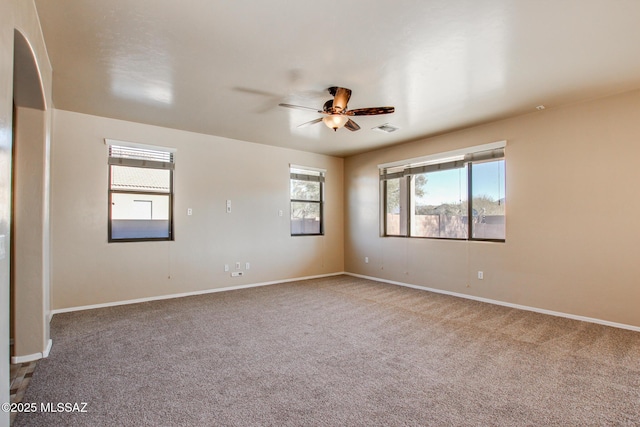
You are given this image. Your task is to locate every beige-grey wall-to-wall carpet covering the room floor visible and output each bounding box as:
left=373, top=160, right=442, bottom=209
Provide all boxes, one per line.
left=14, top=276, right=640, bottom=426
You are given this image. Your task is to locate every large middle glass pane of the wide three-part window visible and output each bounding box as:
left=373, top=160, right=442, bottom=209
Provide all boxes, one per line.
left=411, top=168, right=468, bottom=239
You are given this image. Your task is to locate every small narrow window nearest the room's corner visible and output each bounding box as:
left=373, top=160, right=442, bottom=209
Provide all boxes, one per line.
left=289, top=165, right=325, bottom=236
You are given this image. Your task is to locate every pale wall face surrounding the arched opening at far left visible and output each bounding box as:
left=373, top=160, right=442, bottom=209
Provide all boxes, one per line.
left=0, top=0, right=52, bottom=426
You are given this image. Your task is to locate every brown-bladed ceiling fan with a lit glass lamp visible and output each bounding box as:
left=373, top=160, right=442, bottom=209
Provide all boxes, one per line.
left=278, top=86, right=395, bottom=132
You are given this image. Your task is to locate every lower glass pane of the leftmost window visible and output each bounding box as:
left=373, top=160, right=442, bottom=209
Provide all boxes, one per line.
left=111, top=193, right=170, bottom=240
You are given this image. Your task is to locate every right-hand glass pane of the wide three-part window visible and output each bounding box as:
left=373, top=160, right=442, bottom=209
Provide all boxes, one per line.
left=471, top=160, right=506, bottom=240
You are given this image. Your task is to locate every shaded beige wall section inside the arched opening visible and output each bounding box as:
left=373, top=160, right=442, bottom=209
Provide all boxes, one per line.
left=11, top=107, right=49, bottom=357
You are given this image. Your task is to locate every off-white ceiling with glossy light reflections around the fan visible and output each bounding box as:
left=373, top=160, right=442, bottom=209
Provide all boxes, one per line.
left=36, top=0, right=640, bottom=156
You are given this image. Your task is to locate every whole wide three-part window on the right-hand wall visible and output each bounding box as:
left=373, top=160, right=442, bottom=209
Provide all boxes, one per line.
left=380, top=142, right=506, bottom=241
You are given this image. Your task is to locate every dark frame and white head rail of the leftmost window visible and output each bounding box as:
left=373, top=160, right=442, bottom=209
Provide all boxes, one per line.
left=105, top=139, right=176, bottom=243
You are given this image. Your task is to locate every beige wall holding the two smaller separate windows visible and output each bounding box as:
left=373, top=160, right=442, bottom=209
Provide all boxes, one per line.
left=51, top=110, right=344, bottom=309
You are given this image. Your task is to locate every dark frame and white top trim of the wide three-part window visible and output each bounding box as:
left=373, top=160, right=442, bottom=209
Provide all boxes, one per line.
left=378, top=141, right=506, bottom=243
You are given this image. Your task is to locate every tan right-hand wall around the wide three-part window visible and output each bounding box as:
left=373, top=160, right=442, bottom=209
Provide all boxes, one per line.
left=345, top=91, right=640, bottom=326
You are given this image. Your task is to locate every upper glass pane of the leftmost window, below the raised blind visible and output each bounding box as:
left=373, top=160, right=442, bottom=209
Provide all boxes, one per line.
left=111, top=165, right=171, bottom=193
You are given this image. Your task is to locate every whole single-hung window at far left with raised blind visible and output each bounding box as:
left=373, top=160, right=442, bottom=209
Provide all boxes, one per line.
left=107, top=140, right=174, bottom=242
